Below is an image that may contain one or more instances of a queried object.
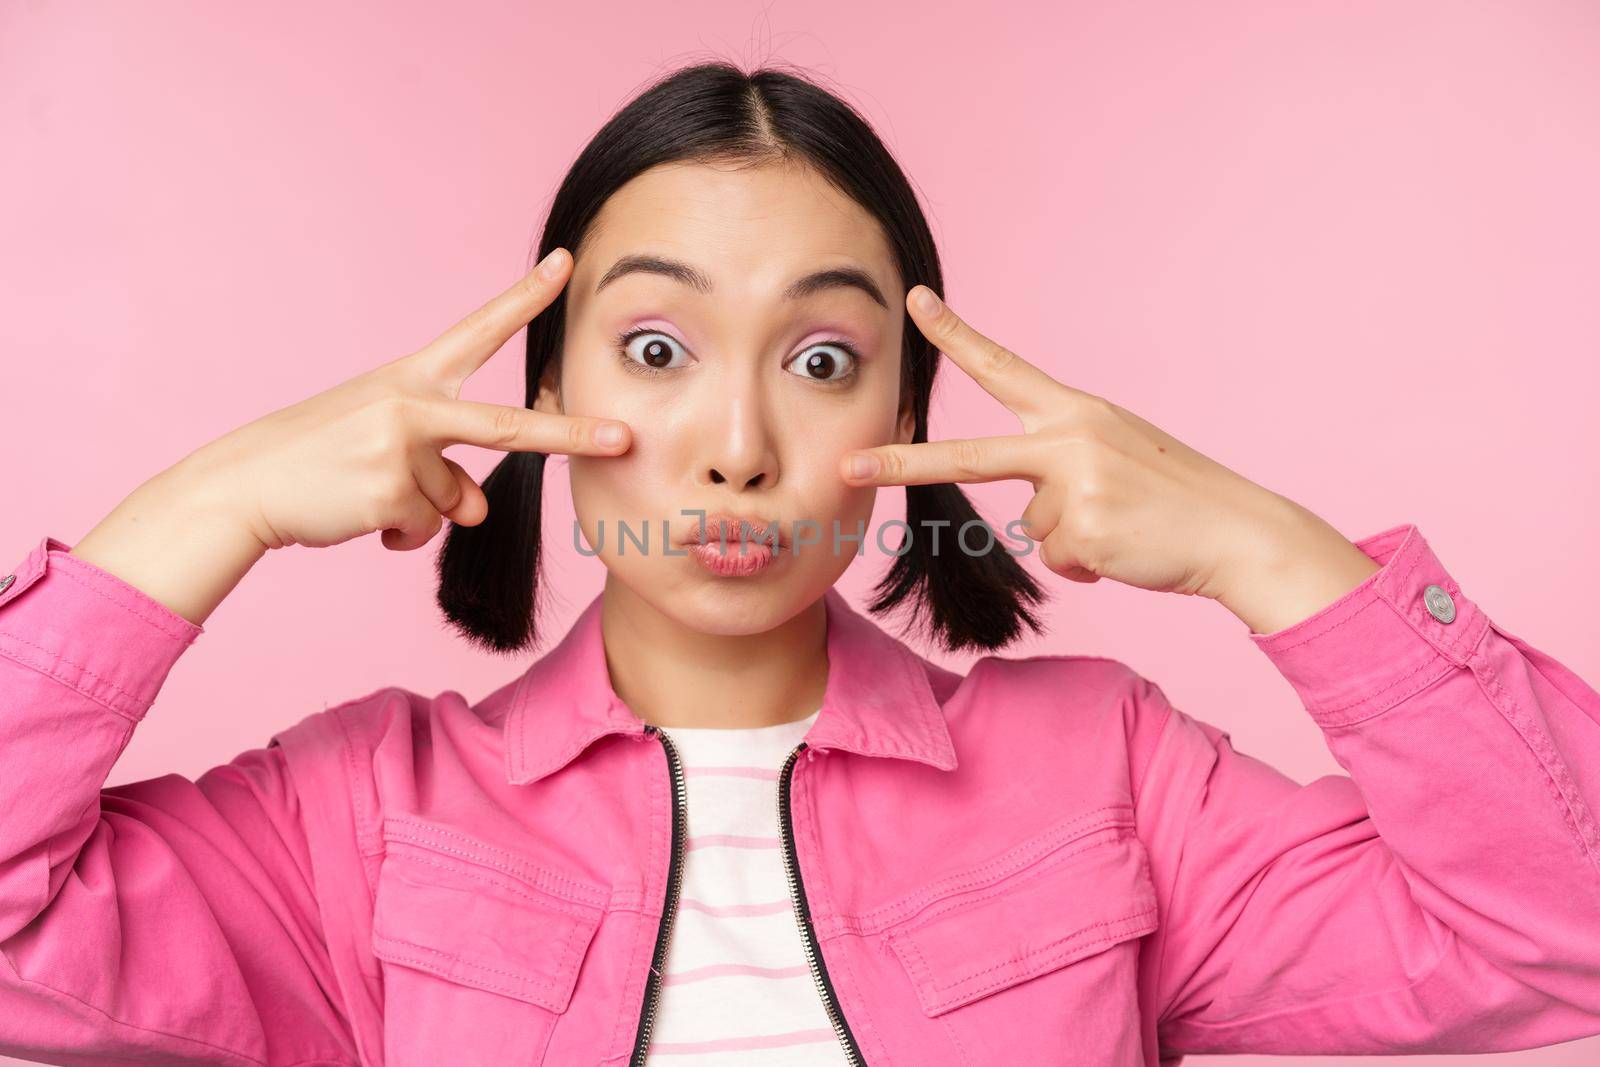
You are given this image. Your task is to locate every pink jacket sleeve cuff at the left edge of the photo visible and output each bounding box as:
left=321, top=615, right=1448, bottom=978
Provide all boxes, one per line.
left=0, top=536, right=205, bottom=721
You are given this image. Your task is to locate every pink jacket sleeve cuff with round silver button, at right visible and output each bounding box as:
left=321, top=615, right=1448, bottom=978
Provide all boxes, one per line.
left=1248, top=523, right=1488, bottom=726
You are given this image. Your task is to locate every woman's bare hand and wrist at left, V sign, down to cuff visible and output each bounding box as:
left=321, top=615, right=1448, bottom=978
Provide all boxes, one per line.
left=69, top=248, right=632, bottom=625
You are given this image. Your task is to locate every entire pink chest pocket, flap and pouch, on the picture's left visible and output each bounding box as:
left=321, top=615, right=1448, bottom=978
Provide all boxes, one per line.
left=373, top=817, right=608, bottom=1067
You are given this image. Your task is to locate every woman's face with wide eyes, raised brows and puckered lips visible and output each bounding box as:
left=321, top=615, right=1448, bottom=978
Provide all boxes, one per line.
left=534, top=163, right=914, bottom=633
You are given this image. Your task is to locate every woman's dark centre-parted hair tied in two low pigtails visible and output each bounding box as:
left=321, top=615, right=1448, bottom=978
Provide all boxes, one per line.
left=437, top=61, right=1042, bottom=651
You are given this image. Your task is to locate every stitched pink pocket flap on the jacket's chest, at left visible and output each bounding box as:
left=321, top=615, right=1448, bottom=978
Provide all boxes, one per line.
left=373, top=840, right=603, bottom=1013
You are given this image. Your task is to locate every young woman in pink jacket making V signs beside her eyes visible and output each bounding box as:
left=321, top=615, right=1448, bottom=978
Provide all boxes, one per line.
left=0, top=64, right=1600, bottom=1065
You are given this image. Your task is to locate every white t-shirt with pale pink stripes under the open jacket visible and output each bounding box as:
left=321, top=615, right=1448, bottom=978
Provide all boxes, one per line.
left=648, top=709, right=848, bottom=1067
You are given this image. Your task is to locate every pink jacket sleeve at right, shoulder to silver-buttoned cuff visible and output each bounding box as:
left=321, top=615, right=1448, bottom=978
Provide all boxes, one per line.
left=1136, top=525, right=1600, bottom=1054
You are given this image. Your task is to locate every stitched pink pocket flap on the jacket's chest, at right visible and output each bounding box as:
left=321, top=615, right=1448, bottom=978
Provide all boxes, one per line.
left=885, top=833, right=1157, bottom=1016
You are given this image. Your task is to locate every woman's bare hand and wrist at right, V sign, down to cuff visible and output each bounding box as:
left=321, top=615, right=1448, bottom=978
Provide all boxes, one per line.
left=840, top=285, right=1378, bottom=633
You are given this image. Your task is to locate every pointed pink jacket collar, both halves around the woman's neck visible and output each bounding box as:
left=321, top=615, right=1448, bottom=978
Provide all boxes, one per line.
left=506, top=587, right=955, bottom=785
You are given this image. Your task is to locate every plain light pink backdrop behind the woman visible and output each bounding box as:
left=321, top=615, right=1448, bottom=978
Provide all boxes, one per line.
left=0, top=0, right=1600, bottom=1064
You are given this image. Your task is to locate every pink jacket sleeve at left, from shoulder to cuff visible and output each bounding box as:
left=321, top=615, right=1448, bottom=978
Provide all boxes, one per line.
left=0, top=537, right=357, bottom=1064
